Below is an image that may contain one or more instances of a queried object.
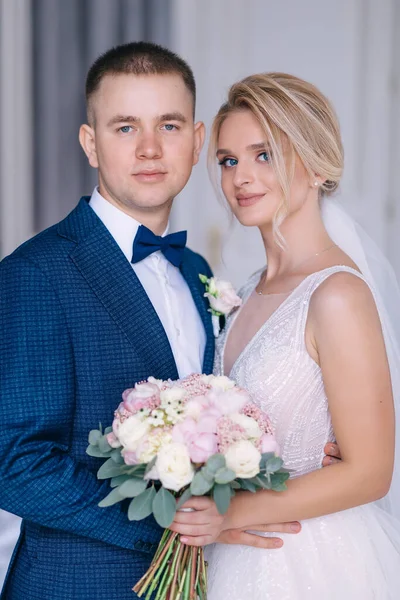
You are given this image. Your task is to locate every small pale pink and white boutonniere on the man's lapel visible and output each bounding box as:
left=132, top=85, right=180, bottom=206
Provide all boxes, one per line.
left=199, top=274, right=242, bottom=337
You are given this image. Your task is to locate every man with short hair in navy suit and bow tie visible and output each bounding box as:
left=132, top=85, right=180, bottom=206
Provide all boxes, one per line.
left=0, top=43, right=338, bottom=600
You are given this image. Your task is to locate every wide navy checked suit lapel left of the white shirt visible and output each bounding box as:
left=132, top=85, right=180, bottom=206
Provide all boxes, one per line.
left=59, top=201, right=178, bottom=379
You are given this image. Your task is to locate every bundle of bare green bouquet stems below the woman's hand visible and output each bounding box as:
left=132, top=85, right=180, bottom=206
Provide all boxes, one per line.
left=133, top=529, right=207, bottom=600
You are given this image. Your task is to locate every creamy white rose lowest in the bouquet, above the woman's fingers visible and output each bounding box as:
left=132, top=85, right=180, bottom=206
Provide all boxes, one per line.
left=155, top=442, right=194, bottom=492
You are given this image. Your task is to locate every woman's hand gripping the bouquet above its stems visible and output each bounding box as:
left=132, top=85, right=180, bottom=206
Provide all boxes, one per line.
left=169, top=496, right=225, bottom=546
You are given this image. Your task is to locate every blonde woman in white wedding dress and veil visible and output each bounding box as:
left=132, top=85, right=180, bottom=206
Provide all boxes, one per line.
left=172, top=73, right=400, bottom=600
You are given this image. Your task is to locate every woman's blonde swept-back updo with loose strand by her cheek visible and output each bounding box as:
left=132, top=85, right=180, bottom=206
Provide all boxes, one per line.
left=208, top=73, right=343, bottom=245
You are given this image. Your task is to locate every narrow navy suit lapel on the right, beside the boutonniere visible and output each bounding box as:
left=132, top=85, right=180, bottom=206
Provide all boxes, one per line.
left=180, top=251, right=215, bottom=374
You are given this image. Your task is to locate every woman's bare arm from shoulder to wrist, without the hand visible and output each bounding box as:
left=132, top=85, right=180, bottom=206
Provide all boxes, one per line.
left=224, top=272, right=394, bottom=527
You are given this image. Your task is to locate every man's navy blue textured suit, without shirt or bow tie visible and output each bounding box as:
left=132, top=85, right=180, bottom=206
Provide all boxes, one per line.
left=0, top=198, right=214, bottom=600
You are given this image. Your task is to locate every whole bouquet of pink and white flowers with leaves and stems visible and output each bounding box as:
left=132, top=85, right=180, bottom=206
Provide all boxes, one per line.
left=87, top=375, right=289, bottom=600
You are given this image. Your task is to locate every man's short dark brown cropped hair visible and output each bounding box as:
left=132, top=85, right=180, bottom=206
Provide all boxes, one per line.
left=86, top=42, right=196, bottom=122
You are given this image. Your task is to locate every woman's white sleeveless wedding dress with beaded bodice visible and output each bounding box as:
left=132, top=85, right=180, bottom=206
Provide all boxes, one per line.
left=206, top=266, right=400, bottom=600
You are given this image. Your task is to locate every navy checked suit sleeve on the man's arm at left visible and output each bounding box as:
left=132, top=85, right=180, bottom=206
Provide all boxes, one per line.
left=0, top=257, right=155, bottom=549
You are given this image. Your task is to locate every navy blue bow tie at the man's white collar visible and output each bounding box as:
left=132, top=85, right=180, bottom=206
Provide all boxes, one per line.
left=131, top=225, right=187, bottom=267
